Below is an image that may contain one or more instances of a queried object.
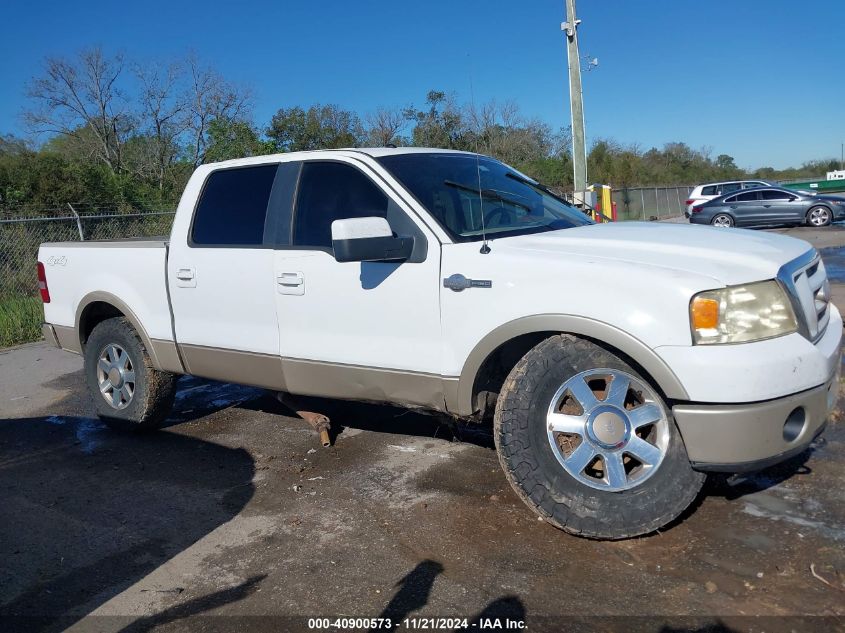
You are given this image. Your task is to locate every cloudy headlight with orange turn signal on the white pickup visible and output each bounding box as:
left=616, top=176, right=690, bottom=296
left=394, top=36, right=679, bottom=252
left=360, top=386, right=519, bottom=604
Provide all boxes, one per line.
left=690, top=281, right=798, bottom=345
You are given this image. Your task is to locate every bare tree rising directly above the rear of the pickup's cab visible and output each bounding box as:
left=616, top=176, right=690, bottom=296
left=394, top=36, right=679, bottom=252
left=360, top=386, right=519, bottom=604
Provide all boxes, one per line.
left=187, top=55, right=252, bottom=165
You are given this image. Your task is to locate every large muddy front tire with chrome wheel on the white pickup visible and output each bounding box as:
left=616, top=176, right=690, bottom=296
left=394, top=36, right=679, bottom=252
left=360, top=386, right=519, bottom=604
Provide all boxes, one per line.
left=494, top=334, right=705, bottom=539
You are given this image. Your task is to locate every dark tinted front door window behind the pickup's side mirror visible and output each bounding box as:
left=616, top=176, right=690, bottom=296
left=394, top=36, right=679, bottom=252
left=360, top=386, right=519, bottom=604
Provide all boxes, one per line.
left=293, top=162, right=388, bottom=248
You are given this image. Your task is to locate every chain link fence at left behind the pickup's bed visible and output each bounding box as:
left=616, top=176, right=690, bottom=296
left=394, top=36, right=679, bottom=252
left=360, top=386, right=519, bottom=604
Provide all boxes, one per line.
left=0, top=208, right=175, bottom=347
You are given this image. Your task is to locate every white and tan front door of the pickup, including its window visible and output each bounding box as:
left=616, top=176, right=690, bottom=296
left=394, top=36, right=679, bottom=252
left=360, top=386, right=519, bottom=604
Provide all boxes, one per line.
left=275, top=157, right=443, bottom=408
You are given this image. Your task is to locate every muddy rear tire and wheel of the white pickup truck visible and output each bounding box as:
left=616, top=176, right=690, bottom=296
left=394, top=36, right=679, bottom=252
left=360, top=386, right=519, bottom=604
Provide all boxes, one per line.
left=85, top=317, right=176, bottom=431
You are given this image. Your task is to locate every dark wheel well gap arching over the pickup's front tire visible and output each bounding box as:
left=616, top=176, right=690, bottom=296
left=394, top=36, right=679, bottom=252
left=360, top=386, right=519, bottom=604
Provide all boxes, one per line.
left=472, top=331, right=671, bottom=417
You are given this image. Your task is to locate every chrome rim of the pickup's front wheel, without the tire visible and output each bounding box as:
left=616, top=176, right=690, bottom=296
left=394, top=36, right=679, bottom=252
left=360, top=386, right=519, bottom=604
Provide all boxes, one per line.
left=546, top=369, right=669, bottom=491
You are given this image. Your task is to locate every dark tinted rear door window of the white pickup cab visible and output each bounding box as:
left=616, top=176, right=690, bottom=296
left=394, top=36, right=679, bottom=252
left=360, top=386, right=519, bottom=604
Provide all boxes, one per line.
left=191, top=165, right=278, bottom=246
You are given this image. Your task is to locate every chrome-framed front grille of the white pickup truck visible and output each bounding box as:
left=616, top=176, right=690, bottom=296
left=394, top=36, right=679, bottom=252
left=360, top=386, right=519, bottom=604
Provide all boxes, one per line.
left=778, top=249, right=830, bottom=341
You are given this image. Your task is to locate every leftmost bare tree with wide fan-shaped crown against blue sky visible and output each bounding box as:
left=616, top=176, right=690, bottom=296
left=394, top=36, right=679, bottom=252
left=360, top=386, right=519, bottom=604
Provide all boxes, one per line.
left=24, top=47, right=132, bottom=172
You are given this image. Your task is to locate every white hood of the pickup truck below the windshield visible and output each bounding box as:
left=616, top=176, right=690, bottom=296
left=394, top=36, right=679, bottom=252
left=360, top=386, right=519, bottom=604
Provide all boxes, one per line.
left=494, top=222, right=812, bottom=285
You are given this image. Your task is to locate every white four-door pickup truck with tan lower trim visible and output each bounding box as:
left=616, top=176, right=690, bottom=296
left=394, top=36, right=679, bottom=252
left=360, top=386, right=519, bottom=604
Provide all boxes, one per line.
left=39, top=149, right=842, bottom=539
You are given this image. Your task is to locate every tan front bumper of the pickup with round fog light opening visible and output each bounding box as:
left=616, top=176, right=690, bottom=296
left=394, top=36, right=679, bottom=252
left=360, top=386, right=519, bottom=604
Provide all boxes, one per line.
left=672, top=370, right=839, bottom=472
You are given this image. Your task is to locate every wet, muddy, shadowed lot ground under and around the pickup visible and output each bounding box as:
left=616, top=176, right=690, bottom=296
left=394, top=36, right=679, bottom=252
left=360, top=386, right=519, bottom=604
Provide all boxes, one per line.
left=0, top=227, right=845, bottom=631
